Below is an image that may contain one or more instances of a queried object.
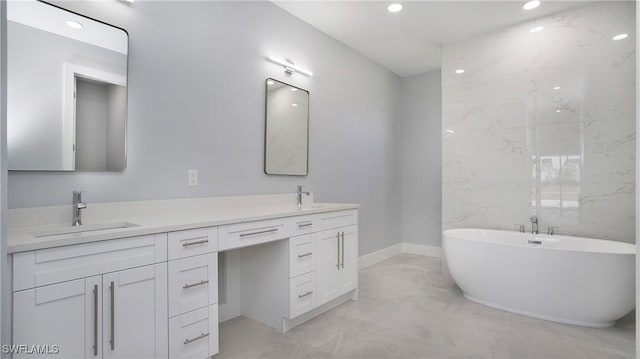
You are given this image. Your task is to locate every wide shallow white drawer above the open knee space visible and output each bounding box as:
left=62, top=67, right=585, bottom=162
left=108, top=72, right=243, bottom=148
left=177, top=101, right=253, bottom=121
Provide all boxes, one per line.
left=219, top=218, right=287, bottom=251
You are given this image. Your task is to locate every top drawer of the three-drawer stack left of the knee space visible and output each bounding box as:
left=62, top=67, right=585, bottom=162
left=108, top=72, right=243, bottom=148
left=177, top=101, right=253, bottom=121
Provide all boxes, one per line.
left=168, top=227, right=218, bottom=260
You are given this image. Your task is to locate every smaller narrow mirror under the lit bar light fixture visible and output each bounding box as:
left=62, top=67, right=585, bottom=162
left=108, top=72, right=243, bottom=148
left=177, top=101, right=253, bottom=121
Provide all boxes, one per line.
left=264, top=79, right=309, bottom=176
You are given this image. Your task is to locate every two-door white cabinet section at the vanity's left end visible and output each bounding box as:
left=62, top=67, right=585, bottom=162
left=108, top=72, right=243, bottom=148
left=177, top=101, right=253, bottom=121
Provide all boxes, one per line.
left=13, top=235, right=167, bottom=358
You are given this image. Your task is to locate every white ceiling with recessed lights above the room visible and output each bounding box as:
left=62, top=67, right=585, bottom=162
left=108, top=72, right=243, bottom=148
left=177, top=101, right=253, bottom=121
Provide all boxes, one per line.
left=273, top=0, right=590, bottom=77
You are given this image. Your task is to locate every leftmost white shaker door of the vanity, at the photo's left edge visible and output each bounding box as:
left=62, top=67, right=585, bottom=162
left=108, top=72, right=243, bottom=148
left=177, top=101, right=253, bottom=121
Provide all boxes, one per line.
left=13, top=276, right=102, bottom=358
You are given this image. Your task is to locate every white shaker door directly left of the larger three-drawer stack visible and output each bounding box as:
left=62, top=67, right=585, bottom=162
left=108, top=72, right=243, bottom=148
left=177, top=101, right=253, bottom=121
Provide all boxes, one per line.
left=102, top=263, right=168, bottom=358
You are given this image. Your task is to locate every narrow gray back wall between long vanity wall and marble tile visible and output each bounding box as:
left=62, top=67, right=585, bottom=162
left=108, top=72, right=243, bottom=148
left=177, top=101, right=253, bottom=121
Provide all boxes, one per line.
left=396, top=70, right=442, bottom=247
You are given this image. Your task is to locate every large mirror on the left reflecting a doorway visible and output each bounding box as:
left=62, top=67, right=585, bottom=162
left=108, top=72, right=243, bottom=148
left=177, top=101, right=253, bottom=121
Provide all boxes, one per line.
left=7, top=0, right=129, bottom=171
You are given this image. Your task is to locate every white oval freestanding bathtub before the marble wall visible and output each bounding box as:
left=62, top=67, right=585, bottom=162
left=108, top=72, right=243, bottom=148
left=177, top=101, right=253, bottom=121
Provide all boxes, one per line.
left=443, top=228, right=636, bottom=327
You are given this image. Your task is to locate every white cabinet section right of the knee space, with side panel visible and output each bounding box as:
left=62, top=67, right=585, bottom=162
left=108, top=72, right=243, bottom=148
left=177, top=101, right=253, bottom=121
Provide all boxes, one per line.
left=240, top=210, right=358, bottom=332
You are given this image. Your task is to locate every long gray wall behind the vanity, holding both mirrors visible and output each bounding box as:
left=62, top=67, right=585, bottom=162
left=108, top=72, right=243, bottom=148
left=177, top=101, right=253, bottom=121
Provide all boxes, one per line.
left=9, top=1, right=400, bottom=254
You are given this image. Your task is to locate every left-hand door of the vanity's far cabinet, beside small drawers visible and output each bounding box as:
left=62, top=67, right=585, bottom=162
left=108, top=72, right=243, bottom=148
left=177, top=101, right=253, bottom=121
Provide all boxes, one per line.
left=315, top=230, right=341, bottom=305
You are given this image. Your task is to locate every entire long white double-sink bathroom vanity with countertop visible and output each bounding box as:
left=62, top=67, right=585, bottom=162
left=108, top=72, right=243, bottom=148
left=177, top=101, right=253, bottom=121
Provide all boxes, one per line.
left=9, top=195, right=359, bottom=358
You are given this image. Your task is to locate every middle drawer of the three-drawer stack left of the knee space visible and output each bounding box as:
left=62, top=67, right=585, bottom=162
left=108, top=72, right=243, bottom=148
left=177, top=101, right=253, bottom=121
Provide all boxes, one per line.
left=168, top=253, right=218, bottom=317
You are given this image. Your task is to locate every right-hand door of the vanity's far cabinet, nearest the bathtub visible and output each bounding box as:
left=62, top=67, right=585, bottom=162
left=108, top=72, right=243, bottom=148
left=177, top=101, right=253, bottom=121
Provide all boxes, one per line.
left=336, top=226, right=358, bottom=295
